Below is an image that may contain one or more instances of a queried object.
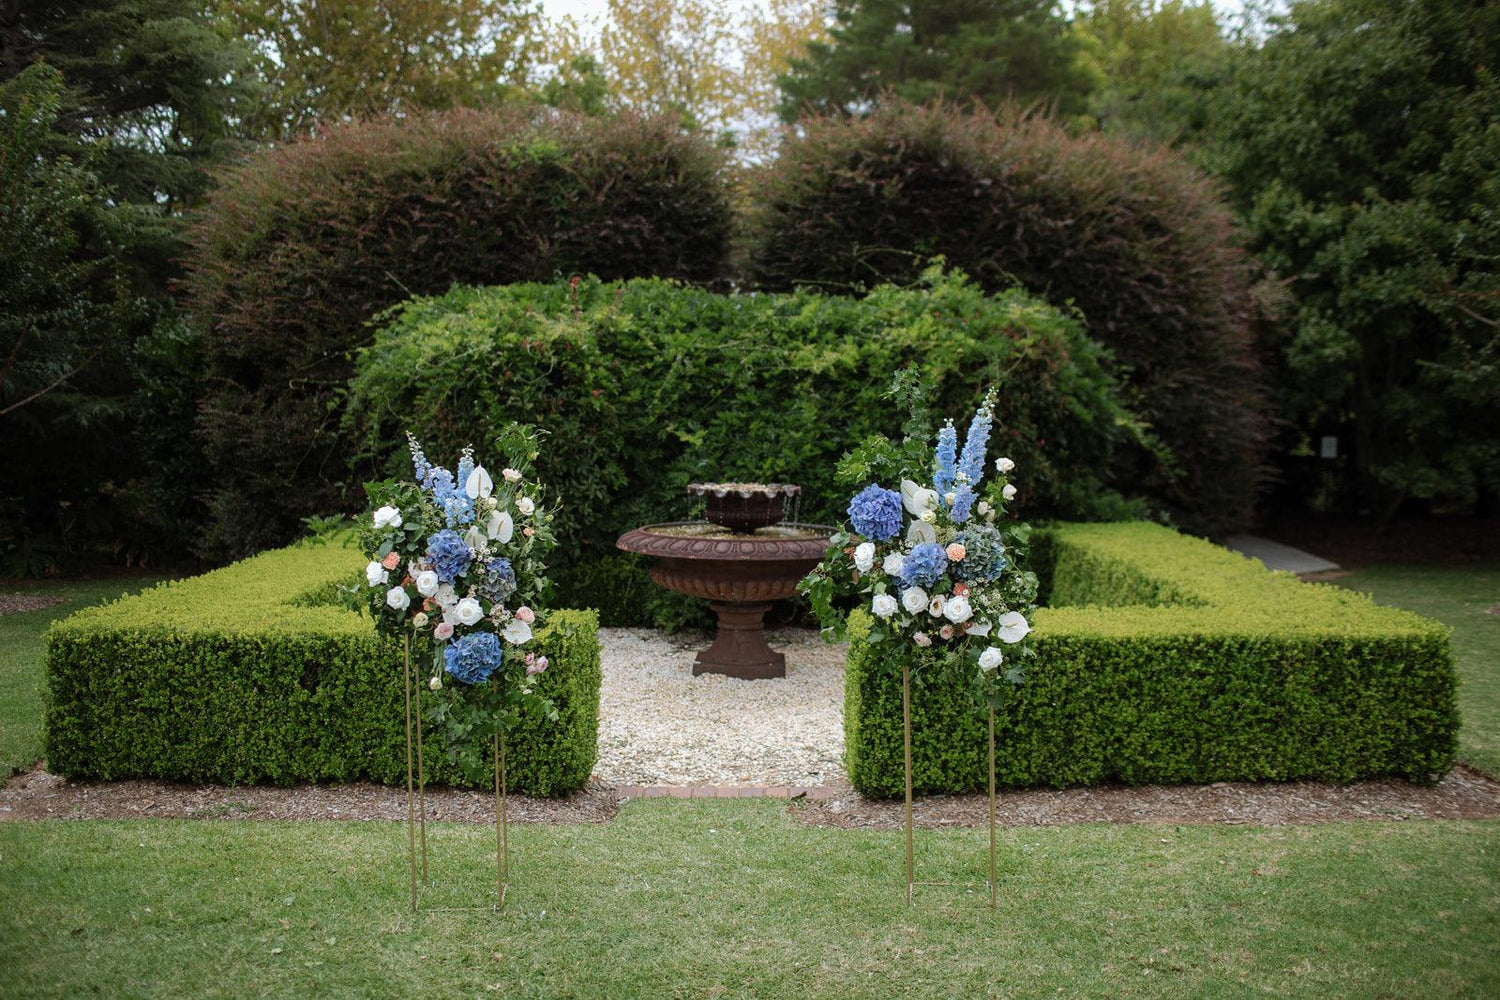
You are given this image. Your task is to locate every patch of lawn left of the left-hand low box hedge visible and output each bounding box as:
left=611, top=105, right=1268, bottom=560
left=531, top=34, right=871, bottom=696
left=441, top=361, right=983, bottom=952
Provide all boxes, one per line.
left=0, top=576, right=161, bottom=778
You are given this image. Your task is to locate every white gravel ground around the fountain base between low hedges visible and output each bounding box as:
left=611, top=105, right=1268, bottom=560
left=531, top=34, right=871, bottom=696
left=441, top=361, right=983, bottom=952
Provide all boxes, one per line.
left=594, top=628, right=846, bottom=786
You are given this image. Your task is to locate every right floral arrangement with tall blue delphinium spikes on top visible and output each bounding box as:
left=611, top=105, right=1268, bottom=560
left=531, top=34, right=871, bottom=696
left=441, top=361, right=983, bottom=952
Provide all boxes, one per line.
left=801, top=370, right=1037, bottom=706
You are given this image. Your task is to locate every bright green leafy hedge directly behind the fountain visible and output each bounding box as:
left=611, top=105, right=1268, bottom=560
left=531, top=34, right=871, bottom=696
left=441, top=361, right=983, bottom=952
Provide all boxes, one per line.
left=348, top=274, right=1128, bottom=624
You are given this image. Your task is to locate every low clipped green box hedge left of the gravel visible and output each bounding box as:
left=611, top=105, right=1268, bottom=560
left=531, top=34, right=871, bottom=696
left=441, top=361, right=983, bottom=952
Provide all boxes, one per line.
left=47, top=541, right=600, bottom=795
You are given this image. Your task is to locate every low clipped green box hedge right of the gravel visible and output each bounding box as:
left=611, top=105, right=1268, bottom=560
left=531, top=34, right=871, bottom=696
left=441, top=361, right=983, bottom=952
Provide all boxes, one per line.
left=845, top=522, right=1458, bottom=796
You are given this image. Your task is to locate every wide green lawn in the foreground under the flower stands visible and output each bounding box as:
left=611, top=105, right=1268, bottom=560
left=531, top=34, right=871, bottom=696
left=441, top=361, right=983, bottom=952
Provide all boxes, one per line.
left=0, top=799, right=1500, bottom=999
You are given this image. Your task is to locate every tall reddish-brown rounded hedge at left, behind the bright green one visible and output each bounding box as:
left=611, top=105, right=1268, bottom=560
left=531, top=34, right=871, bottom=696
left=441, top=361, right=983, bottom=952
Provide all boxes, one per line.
left=186, top=109, right=731, bottom=558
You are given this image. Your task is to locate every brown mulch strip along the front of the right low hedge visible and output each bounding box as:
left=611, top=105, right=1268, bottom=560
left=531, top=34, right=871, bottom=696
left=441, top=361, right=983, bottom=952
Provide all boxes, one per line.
left=797, top=766, right=1500, bottom=829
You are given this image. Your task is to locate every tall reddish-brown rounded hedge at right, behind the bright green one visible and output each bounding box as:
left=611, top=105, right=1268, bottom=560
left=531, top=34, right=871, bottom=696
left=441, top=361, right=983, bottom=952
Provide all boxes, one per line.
left=750, top=103, right=1266, bottom=534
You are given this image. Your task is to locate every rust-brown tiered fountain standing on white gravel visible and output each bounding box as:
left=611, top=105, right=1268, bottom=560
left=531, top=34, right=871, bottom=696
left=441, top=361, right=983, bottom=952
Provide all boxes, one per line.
left=615, top=483, right=834, bottom=679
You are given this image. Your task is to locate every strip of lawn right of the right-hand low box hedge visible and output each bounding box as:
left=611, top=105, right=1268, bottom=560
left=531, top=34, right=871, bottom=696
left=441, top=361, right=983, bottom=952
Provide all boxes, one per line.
left=1338, top=564, right=1500, bottom=775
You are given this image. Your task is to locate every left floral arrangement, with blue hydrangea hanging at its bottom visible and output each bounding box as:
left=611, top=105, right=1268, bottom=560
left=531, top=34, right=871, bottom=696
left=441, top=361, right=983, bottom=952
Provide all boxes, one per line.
left=345, top=424, right=557, bottom=775
